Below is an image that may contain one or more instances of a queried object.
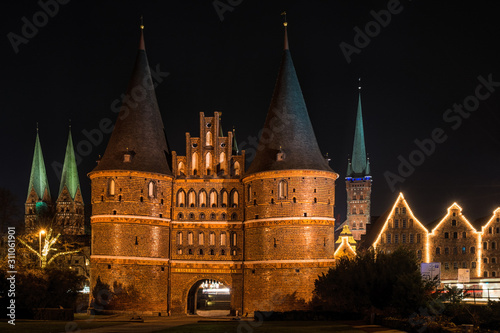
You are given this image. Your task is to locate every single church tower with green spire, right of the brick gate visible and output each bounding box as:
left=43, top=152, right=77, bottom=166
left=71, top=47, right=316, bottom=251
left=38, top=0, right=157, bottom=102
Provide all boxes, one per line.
left=341, top=79, right=372, bottom=241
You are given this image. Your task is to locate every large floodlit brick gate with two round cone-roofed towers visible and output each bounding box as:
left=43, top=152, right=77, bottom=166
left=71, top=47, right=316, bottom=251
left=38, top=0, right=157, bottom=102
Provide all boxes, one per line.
left=89, top=24, right=338, bottom=315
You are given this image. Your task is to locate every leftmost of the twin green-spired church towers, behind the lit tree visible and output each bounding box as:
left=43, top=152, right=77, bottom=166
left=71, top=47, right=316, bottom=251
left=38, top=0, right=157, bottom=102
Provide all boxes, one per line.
left=24, top=125, right=52, bottom=231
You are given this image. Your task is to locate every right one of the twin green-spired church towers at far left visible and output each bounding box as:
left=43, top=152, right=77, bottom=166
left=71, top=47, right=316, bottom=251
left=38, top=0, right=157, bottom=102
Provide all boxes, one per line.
left=56, top=128, right=85, bottom=235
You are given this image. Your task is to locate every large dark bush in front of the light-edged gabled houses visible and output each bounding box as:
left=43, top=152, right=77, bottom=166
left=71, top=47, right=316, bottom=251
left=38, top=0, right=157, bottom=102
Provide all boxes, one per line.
left=315, top=248, right=433, bottom=315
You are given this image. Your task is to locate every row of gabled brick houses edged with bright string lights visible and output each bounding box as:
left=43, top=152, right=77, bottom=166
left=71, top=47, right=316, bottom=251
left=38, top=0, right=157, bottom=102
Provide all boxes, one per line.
left=366, top=193, right=500, bottom=282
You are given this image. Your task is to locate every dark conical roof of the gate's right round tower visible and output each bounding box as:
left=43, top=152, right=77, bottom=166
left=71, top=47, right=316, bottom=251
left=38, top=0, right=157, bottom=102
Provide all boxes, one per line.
left=247, top=26, right=333, bottom=174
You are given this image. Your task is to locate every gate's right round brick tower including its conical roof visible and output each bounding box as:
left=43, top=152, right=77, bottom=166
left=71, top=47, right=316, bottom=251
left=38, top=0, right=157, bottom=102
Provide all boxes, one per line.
left=243, top=23, right=338, bottom=313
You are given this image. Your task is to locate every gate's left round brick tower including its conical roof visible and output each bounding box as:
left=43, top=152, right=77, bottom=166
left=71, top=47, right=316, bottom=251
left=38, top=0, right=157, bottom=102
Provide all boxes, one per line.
left=89, top=26, right=173, bottom=311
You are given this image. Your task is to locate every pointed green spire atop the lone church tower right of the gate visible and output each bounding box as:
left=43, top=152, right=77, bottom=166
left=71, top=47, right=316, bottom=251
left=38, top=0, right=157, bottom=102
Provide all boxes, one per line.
left=347, top=79, right=370, bottom=177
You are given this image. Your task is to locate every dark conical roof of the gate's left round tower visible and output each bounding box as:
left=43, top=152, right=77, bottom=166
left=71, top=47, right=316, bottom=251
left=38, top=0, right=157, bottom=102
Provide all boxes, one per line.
left=94, top=30, right=172, bottom=175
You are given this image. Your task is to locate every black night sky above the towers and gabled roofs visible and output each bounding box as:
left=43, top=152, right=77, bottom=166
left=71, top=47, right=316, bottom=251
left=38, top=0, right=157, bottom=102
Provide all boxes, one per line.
left=0, top=0, right=500, bottom=223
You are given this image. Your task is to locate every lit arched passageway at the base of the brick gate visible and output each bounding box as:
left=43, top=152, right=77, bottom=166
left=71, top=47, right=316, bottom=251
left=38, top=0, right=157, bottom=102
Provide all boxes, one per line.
left=187, top=279, right=231, bottom=316
